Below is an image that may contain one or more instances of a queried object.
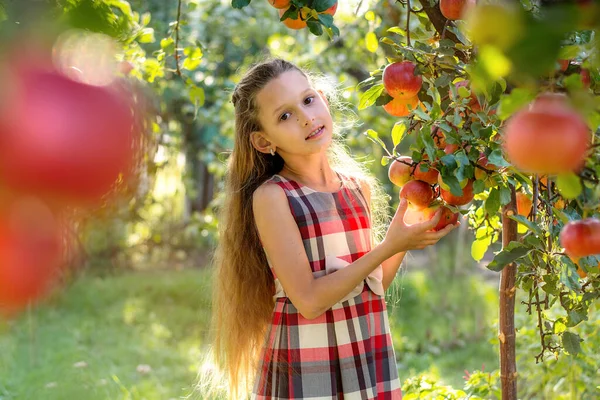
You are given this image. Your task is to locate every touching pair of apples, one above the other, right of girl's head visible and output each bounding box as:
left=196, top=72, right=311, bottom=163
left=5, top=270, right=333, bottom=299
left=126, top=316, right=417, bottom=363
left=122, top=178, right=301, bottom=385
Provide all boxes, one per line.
left=382, top=61, right=423, bottom=117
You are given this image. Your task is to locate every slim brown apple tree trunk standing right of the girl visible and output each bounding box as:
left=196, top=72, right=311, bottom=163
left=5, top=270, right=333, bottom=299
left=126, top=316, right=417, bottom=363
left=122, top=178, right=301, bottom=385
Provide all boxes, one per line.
left=498, top=186, right=517, bottom=400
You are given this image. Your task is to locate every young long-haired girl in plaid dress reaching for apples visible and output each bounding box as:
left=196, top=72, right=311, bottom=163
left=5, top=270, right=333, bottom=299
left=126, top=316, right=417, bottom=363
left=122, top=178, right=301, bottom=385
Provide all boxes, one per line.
left=213, top=59, right=453, bottom=400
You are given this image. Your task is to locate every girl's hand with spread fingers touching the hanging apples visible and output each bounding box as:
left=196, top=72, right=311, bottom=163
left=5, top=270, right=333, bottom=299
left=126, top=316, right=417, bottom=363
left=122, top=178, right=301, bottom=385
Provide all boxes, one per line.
left=382, top=199, right=460, bottom=254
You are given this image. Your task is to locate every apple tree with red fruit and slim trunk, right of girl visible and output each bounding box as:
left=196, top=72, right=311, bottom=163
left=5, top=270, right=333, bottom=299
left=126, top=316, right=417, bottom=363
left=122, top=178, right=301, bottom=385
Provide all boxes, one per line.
left=359, top=0, right=600, bottom=399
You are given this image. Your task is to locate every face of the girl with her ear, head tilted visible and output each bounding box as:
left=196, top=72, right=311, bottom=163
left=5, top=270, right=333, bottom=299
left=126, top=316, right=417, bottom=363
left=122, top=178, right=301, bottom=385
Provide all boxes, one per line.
left=252, top=70, right=333, bottom=158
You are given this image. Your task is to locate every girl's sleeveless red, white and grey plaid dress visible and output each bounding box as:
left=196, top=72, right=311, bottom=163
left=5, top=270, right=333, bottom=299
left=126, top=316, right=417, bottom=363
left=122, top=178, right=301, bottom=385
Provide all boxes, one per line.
left=252, top=173, right=402, bottom=400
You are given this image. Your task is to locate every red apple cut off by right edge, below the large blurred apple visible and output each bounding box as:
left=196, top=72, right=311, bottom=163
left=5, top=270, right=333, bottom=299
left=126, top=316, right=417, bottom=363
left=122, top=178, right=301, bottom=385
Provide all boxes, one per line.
left=560, top=218, right=600, bottom=260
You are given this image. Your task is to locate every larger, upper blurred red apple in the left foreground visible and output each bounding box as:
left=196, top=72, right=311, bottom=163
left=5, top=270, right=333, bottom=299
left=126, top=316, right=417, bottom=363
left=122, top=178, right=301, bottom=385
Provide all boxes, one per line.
left=0, top=60, right=136, bottom=209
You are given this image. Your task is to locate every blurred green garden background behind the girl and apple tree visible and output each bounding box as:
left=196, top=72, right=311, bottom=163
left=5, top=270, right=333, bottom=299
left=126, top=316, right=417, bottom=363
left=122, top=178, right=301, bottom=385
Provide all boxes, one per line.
left=0, top=0, right=600, bottom=400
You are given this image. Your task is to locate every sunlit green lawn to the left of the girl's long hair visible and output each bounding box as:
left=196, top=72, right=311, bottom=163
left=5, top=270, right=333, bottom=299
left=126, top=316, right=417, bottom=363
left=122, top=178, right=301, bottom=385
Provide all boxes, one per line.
left=0, top=271, right=210, bottom=400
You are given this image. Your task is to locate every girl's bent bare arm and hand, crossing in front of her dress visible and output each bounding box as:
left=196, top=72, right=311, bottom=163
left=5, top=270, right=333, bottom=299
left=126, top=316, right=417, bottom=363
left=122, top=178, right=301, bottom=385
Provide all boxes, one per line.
left=253, top=184, right=449, bottom=319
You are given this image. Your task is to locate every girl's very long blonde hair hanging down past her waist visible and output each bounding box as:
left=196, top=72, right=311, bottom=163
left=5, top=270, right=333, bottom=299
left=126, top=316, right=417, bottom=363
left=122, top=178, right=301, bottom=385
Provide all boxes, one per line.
left=212, top=59, right=387, bottom=398
